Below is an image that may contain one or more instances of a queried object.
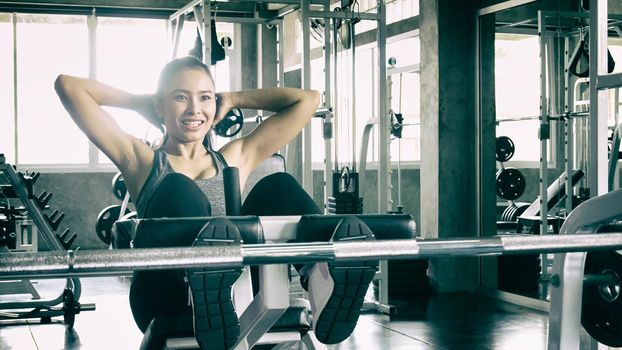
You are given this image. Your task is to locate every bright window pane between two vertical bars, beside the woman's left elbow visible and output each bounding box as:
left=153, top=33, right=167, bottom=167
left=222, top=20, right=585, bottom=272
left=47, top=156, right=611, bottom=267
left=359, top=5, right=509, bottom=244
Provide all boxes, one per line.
left=15, top=14, right=88, bottom=164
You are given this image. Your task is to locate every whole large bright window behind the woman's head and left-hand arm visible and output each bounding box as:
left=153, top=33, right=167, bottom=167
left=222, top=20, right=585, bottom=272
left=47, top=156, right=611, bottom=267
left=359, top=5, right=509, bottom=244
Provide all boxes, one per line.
left=0, top=13, right=213, bottom=170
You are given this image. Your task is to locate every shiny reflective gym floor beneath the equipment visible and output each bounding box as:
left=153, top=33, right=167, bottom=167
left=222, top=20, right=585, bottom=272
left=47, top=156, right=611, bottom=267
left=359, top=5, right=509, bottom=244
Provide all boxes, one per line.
left=0, top=277, right=604, bottom=350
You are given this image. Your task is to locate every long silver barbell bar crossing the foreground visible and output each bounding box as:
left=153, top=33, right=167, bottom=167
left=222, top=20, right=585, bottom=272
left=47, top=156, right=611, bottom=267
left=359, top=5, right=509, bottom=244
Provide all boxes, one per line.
left=0, top=232, right=622, bottom=280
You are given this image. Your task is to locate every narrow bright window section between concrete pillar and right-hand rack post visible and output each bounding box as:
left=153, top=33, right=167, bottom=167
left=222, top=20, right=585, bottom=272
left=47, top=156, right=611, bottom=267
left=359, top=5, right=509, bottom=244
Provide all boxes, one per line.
left=495, top=34, right=540, bottom=161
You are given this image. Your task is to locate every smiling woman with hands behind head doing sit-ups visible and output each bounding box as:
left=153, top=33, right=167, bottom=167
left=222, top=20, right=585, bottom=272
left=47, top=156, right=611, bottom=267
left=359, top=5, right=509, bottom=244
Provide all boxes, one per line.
left=55, top=56, right=378, bottom=349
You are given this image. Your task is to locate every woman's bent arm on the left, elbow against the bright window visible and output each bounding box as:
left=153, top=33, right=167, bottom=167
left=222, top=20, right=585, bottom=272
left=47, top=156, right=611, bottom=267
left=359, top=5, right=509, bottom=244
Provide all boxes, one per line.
left=54, top=75, right=155, bottom=171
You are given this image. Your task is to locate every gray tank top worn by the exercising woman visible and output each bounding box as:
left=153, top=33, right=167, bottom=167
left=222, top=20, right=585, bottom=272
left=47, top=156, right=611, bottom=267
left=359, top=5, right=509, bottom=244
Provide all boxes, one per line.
left=135, top=148, right=227, bottom=218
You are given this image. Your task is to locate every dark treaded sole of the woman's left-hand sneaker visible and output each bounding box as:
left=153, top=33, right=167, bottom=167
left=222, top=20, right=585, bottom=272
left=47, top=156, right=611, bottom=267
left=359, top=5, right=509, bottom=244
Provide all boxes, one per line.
left=186, top=218, right=242, bottom=350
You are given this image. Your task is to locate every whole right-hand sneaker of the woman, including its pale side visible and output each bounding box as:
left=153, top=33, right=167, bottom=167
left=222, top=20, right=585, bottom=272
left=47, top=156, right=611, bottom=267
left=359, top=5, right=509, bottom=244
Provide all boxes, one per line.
left=309, top=216, right=378, bottom=344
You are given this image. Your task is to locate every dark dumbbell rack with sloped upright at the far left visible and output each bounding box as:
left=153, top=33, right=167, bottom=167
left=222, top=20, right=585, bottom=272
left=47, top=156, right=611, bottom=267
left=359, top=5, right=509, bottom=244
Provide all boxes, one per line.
left=0, top=159, right=95, bottom=328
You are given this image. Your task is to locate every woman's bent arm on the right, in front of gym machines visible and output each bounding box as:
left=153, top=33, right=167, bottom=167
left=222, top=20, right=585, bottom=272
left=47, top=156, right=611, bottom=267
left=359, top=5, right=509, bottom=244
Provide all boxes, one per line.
left=221, top=88, right=320, bottom=174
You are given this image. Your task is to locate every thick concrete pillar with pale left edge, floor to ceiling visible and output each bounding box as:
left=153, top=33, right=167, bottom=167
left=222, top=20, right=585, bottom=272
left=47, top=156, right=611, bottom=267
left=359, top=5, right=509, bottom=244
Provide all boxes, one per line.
left=420, top=0, right=479, bottom=293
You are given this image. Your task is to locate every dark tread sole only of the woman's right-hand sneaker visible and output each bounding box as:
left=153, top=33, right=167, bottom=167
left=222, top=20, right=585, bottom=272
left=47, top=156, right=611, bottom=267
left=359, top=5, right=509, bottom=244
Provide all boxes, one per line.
left=315, top=216, right=378, bottom=344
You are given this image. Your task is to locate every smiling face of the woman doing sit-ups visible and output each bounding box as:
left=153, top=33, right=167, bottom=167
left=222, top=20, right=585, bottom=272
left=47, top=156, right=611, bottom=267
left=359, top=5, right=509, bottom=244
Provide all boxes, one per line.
left=159, top=69, right=216, bottom=143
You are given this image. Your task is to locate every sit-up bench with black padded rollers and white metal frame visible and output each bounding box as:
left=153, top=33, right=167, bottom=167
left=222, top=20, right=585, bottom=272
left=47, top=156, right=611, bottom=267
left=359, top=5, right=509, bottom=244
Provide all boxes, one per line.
left=116, top=215, right=415, bottom=349
